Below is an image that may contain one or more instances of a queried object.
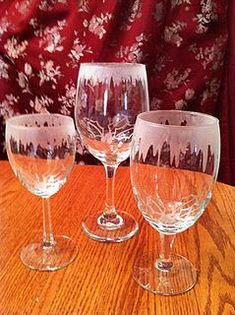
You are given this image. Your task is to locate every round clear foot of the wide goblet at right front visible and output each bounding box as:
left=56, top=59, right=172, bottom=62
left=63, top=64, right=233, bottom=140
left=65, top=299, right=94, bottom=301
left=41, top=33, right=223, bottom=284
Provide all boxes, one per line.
left=133, top=252, right=197, bottom=295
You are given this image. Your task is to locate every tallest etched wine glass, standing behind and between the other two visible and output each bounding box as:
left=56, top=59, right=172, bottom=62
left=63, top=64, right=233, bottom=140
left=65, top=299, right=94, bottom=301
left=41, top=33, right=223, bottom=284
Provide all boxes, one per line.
left=75, top=63, right=149, bottom=242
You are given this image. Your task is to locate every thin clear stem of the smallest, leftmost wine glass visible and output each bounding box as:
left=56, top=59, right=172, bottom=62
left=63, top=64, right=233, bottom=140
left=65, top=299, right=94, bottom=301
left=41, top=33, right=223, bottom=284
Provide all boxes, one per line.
left=42, top=198, right=55, bottom=247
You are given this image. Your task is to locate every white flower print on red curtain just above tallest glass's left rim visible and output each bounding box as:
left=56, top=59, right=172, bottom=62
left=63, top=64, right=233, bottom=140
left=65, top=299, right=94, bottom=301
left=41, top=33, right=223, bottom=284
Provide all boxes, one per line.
left=66, top=31, right=93, bottom=68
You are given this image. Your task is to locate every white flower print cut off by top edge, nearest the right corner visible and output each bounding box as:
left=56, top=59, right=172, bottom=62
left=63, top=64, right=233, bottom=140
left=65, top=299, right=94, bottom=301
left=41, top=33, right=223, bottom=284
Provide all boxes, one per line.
left=193, top=0, right=218, bottom=34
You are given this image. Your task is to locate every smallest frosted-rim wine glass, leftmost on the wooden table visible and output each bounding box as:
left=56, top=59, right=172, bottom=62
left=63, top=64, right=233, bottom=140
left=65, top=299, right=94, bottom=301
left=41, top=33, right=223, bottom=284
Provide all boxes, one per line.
left=6, top=114, right=77, bottom=271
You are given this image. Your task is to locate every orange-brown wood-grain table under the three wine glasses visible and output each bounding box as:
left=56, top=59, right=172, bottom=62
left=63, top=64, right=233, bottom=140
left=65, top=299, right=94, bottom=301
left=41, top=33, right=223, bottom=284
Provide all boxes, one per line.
left=0, top=161, right=235, bottom=315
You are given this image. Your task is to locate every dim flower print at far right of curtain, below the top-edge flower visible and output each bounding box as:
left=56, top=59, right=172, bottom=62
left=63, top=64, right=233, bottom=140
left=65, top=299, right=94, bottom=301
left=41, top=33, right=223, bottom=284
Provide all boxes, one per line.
left=189, top=35, right=227, bottom=70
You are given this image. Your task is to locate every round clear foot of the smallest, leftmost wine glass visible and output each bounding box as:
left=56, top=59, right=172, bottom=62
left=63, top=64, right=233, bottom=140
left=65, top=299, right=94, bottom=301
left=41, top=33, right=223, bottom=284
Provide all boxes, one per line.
left=20, top=235, right=78, bottom=271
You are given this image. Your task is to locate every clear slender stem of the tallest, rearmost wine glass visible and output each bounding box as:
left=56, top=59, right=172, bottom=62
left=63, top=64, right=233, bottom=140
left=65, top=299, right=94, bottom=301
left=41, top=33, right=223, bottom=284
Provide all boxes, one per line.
left=104, top=164, right=117, bottom=218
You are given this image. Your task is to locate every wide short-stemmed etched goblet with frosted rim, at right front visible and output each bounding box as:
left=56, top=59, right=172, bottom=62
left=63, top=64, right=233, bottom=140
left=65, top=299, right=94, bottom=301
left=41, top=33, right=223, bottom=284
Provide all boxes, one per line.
left=131, top=110, right=220, bottom=295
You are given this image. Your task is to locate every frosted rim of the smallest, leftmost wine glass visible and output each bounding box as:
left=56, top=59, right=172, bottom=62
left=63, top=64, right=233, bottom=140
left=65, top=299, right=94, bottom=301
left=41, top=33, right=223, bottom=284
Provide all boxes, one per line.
left=6, top=113, right=74, bottom=130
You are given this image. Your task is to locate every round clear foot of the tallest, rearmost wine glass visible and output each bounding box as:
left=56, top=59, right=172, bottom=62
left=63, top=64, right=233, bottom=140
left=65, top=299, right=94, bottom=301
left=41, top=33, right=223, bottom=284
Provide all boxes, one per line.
left=82, top=212, right=139, bottom=243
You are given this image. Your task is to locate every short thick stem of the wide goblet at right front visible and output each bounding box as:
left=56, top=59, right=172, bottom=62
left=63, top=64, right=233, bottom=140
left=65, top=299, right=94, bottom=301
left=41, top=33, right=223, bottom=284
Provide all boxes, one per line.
left=156, top=233, right=175, bottom=272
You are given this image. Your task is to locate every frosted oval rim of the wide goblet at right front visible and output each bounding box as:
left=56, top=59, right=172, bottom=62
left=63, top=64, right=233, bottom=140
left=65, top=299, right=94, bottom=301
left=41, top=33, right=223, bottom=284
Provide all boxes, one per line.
left=137, top=109, right=219, bottom=129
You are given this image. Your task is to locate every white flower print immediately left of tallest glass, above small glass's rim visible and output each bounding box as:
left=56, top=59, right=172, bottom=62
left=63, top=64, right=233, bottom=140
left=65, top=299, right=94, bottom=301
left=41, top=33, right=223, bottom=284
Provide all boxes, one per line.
left=58, top=82, right=76, bottom=115
